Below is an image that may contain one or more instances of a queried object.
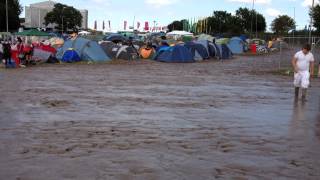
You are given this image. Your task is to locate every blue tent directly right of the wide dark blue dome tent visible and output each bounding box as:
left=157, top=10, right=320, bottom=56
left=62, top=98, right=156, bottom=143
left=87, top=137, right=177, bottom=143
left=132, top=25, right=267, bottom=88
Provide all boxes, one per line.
left=184, top=42, right=209, bottom=60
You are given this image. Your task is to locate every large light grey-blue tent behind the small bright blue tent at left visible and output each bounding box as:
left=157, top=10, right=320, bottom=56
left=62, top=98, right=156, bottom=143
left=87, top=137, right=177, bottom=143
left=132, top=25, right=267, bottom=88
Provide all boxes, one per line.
left=57, top=37, right=111, bottom=62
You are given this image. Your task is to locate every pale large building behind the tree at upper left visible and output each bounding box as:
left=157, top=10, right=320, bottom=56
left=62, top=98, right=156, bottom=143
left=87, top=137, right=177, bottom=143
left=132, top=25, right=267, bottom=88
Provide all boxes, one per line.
left=25, top=0, right=88, bottom=29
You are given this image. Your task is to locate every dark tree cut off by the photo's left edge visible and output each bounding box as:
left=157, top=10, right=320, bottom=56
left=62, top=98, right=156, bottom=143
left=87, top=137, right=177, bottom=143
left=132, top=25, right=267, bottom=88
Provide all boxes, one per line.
left=0, top=0, right=22, bottom=31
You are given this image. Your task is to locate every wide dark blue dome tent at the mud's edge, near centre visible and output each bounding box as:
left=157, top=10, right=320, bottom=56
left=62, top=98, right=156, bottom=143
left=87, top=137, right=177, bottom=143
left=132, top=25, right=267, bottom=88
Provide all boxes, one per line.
left=154, top=45, right=195, bottom=63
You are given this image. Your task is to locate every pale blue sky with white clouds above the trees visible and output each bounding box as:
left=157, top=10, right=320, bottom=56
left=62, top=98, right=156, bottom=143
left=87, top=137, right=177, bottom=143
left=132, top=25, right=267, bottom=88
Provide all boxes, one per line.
left=20, top=0, right=319, bottom=31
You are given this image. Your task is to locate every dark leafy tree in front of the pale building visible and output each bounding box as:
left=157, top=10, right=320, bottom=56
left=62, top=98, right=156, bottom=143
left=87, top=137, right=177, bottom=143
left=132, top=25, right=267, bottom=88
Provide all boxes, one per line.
left=44, top=3, right=82, bottom=31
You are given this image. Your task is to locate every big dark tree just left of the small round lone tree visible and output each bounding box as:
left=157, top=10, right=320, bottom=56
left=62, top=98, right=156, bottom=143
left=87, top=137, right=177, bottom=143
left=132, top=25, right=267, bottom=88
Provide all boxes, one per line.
left=236, top=8, right=267, bottom=33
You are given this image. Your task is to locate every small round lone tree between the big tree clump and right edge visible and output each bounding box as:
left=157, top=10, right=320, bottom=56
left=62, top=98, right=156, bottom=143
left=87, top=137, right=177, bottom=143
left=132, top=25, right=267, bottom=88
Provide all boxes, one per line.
left=271, top=15, right=296, bottom=35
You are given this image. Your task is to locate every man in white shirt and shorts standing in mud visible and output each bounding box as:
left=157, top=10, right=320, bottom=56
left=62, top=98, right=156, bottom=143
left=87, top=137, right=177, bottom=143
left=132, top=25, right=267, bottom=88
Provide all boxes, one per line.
left=292, top=44, right=314, bottom=101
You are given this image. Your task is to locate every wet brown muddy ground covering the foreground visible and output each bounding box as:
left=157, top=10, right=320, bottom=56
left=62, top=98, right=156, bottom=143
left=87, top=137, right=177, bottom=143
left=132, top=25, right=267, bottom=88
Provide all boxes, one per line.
left=0, top=51, right=320, bottom=180
